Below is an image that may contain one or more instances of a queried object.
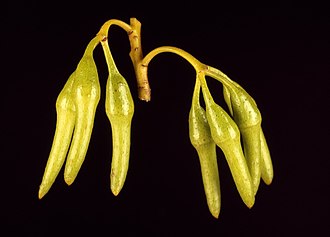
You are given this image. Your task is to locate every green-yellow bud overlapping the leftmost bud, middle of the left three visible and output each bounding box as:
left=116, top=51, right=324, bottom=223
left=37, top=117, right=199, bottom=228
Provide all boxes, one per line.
left=64, top=38, right=100, bottom=185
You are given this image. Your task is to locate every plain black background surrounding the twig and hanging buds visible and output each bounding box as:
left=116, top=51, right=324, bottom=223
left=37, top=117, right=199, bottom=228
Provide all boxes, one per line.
left=0, top=1, right=330, bottom=236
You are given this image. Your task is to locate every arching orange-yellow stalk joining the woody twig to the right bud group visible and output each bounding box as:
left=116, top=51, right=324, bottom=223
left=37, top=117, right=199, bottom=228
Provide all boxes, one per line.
left=142, top=46, right=207, bottom=73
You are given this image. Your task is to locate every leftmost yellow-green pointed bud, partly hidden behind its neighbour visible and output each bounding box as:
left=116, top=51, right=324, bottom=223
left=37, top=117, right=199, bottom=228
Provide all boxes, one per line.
left=39, top=73, right=76, bottom=199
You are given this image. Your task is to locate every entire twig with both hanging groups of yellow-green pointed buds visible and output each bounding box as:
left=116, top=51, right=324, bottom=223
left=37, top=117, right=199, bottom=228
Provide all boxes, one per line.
left=39, top=18, right=273, bottom=218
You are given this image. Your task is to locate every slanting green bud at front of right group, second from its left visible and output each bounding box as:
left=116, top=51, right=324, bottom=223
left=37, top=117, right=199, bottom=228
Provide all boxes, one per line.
left=202, top=75, right=254, bottom=208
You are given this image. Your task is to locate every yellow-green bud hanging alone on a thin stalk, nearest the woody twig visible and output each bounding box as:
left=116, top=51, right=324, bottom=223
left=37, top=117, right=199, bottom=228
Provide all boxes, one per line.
left=105, top=45, right=134, bottom=196
